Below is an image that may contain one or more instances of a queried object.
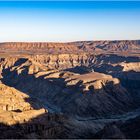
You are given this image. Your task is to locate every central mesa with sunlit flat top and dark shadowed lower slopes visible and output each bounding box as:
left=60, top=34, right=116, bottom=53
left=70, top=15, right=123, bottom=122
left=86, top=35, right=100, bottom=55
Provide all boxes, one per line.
left=59, top=72, right=132, bottom=117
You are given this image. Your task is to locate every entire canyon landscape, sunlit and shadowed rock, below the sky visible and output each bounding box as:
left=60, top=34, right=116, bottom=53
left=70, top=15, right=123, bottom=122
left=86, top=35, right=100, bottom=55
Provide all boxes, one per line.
left=0, top=40, right=140, bottom=138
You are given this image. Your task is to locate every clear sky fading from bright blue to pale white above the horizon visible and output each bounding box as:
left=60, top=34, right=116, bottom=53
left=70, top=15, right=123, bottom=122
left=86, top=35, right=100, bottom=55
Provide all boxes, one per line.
left=0, top=1, right=140, bottom=42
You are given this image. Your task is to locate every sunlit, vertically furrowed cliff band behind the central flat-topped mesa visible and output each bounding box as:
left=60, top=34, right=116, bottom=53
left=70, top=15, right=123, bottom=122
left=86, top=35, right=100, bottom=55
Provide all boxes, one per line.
left=30, top=53, right=95, bottom=69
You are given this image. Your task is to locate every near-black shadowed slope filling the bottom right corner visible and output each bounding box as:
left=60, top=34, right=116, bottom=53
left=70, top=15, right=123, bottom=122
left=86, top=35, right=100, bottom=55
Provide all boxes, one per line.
left=93, top=116, right=140, bottom=139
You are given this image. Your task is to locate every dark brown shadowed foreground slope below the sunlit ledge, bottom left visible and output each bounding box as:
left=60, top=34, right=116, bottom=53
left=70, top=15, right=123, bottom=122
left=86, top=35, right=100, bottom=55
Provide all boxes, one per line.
left=0, top=113, right=68, bottom=139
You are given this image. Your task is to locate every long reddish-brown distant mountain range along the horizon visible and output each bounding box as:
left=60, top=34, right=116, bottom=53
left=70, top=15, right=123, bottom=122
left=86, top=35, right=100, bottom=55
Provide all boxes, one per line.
left=0, top=40, right=140, bottom=54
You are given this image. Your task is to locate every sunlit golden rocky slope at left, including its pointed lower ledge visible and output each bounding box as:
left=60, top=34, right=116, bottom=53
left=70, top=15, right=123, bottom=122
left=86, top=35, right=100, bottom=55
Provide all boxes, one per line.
left=0, top=84, right=47, bottom=125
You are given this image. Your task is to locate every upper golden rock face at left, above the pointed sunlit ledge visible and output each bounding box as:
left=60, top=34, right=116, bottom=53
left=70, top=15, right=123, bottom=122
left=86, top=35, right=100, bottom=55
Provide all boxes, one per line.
left=0, top=84, right=32, bottom=111
